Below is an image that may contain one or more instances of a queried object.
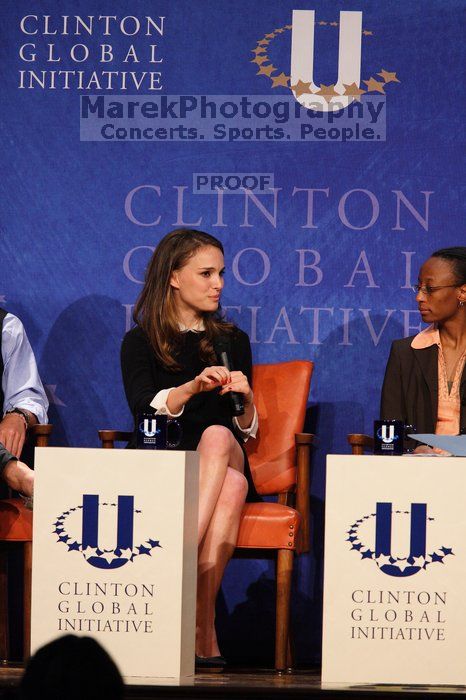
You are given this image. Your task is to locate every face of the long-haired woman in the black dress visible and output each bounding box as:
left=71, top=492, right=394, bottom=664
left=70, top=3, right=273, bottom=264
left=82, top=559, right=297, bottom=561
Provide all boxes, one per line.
left=170, top=245, right=225, bottom=317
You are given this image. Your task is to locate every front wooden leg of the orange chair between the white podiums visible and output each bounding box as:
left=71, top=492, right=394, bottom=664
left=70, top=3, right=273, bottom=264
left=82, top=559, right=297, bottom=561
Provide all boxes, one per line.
left=275, top=549, right=294, bottom=671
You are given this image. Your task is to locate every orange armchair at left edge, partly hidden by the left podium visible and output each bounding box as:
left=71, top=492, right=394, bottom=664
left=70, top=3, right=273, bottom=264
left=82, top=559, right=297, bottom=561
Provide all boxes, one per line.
left=0, top=425, right=52, bottom=661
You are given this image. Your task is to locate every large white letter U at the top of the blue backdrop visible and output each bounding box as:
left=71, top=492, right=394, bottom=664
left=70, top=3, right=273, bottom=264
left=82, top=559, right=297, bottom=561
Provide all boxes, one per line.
left=290, top=10, right=362, bottom=112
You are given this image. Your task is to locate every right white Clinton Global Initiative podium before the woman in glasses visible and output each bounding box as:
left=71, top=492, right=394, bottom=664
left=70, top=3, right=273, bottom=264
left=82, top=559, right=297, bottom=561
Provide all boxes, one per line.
left=322, top=455, right=466, bottom=685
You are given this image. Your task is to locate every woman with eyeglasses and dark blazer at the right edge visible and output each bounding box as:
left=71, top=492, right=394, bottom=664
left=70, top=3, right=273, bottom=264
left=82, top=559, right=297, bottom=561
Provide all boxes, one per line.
left=381, top=246, right=466, bottom=442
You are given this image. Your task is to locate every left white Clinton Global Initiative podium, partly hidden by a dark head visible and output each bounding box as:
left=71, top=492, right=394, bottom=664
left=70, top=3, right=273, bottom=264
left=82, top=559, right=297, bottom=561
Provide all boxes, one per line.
left=31, top=447, right=198, bottom=684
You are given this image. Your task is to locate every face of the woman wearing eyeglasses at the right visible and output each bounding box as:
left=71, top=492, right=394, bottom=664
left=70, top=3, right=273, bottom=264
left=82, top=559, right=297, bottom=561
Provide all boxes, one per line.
left=416, top=258, right=460, bottom=323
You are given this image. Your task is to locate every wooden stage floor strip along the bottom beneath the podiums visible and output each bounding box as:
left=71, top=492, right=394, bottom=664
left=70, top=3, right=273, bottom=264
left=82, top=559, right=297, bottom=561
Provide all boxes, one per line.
left=0, top=665, right=466, bottom=700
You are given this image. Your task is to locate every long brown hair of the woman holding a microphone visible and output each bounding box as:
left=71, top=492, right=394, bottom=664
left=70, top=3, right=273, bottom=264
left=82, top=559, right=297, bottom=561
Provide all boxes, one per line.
left=133, top=229, right=234, bottom=370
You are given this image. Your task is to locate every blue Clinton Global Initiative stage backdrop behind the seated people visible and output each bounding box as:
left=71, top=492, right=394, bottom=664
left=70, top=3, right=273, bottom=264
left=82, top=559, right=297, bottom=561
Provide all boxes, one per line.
left=0, top=0, right=464, bottom=661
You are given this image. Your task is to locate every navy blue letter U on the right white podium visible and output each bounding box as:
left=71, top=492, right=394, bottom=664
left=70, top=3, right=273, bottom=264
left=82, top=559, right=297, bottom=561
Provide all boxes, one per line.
left=375, top=503, right=427, bottom=576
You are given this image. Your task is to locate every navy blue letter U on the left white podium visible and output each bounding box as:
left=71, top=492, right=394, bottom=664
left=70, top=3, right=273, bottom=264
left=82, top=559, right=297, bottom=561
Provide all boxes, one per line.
left=82, top=494, right=134, bottom=569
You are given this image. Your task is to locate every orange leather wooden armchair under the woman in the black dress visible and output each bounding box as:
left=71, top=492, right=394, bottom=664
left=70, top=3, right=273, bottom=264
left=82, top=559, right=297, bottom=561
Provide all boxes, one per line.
left=99, top=360, right=314, bottom=671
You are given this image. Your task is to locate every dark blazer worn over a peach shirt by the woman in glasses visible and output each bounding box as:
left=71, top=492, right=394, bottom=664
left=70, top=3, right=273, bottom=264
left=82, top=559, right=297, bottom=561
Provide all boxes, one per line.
left=380, top=336, right=466, bottom=433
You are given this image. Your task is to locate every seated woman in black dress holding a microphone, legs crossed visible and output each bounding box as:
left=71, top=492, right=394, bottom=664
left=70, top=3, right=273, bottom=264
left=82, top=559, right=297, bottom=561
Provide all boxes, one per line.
left=121, top=229, right=257, bottom=665
